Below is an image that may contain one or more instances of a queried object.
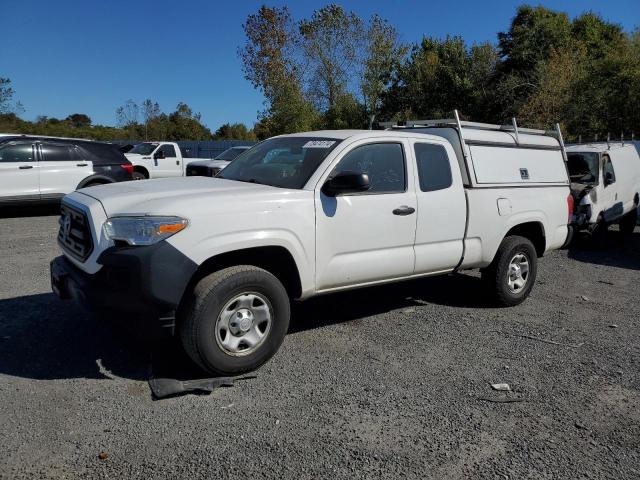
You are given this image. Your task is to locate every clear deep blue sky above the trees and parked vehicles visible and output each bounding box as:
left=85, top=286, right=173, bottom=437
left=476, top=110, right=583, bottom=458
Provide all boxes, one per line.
left=0, top=0, right=640, bottom=130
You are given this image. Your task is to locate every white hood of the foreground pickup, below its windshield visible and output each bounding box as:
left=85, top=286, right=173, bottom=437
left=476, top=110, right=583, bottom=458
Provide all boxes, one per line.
left=79, top=177, right=299, bottom=216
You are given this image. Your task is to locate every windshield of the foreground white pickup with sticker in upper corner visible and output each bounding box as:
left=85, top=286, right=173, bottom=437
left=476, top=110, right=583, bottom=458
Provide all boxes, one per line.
left=217, top=137, right=341, bottom=189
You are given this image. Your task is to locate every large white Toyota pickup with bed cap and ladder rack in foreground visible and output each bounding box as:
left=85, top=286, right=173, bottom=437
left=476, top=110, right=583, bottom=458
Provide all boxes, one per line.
left=51, top=118, right=572, bottom=374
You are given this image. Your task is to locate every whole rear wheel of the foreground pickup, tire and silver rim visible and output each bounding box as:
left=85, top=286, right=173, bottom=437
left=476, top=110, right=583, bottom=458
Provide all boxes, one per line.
left=482, top=235, right=538, bottom=307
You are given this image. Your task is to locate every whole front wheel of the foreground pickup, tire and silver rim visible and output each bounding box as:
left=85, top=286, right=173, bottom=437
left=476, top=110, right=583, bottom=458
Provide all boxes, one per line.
left=178, top=265, right=290, bottom=375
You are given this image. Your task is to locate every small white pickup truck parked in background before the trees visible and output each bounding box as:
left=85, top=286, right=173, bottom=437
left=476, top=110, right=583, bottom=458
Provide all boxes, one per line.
left=124, top=142, right=210, bottom=180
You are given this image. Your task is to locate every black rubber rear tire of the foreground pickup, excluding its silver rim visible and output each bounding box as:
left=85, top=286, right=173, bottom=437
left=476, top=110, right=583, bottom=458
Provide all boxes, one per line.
left=482, top=235, right=538, bottom=307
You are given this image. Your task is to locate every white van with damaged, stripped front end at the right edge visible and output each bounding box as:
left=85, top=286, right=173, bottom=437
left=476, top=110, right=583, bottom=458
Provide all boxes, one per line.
left=567, top=143, right=640, bottom=235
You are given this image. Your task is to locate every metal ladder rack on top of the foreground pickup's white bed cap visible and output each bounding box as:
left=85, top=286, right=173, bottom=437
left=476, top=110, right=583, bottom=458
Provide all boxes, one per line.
left=378, top=110, right=567, bottom=161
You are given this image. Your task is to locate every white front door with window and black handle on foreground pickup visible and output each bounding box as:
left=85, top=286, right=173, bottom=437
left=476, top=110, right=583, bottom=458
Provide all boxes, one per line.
left=315, top=138, right=417, bottom=291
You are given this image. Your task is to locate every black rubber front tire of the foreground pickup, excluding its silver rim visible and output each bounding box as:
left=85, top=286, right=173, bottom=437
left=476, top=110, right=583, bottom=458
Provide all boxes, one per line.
left=178, top=265, right=291, bottom=375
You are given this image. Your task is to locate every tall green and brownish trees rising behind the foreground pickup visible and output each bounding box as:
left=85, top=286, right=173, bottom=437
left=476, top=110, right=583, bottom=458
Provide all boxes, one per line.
left=239, top=4, right=640, bottom=138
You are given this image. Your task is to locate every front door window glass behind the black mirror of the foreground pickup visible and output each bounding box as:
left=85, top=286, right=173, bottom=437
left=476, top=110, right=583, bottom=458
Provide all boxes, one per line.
left=332, top=143, right=407, bottom=194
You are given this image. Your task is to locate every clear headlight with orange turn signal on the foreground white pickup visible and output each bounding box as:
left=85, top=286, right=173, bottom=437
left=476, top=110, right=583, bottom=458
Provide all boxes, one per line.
left=103, top=217, right=188, bottom=245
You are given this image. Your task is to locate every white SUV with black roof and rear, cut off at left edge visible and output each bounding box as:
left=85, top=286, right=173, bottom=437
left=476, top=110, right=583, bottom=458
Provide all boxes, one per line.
left=0, top=134, right=133, bottom=205
